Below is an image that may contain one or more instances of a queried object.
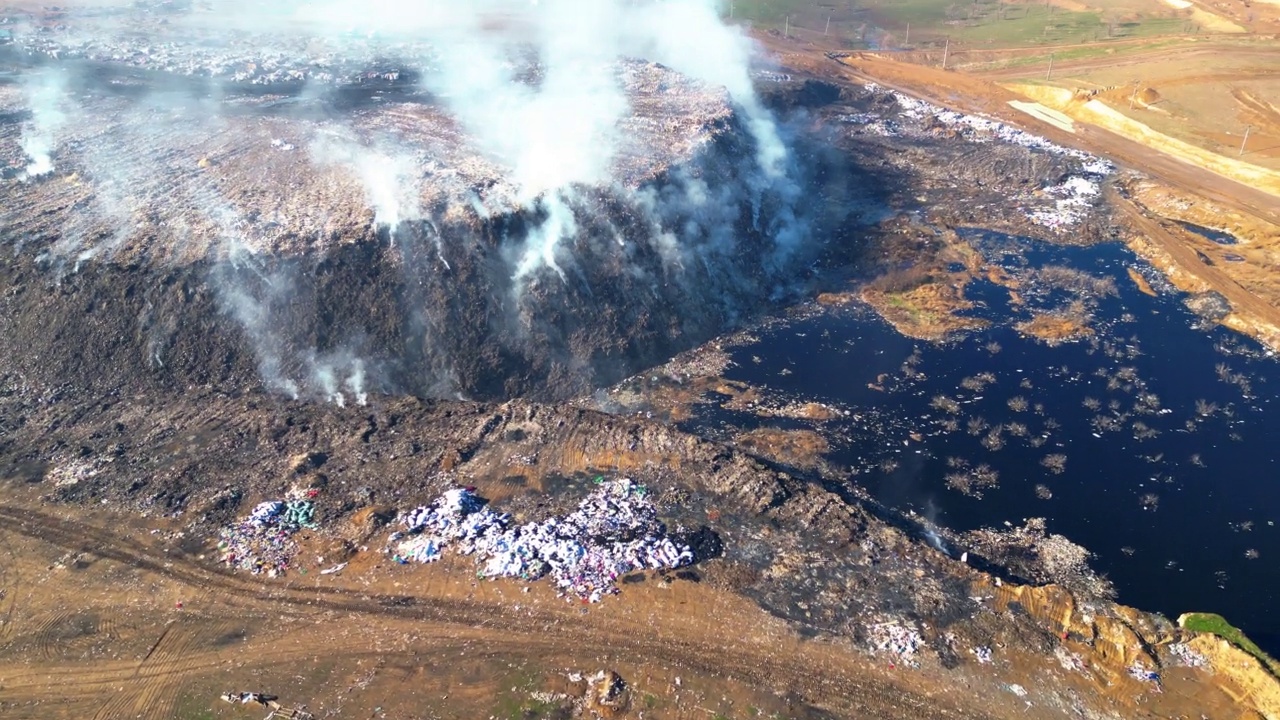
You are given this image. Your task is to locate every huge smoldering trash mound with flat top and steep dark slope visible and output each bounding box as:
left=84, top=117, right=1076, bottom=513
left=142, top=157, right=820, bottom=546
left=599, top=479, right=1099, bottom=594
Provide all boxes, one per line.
left=0, top=53, right=839, bottom=402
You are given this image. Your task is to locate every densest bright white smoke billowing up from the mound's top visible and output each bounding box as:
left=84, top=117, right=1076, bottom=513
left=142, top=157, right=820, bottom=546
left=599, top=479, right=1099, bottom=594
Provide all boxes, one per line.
left=179, top=0, right=801, bottom=281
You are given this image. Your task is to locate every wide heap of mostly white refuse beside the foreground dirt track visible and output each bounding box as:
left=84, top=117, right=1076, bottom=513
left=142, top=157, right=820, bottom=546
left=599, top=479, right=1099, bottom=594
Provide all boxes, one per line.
left=389, top=478, right=694, bottom=602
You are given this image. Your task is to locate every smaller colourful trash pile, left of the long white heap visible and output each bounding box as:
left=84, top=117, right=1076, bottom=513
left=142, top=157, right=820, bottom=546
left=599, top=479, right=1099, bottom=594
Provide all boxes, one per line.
left=218, top=491, right=316, bottom=578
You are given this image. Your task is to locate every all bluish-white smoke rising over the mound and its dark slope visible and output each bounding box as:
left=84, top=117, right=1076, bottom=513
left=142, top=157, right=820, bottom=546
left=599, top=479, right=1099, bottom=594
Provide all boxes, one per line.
left=5, top=0, right=812, bottom=404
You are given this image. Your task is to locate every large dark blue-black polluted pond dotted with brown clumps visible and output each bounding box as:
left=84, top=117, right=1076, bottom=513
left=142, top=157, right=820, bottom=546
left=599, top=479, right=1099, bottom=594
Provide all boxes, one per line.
left=686, top=231, right=1280, bottom=653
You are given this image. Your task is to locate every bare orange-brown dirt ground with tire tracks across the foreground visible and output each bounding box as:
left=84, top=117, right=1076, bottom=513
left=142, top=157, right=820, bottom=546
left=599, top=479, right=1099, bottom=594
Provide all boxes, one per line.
left=0, top=481, right=1259, bottom=720
